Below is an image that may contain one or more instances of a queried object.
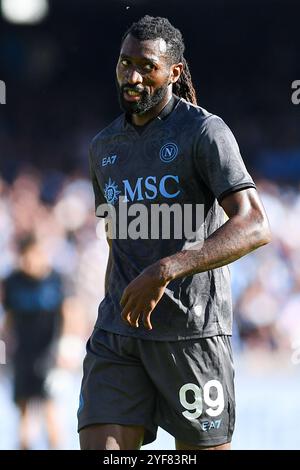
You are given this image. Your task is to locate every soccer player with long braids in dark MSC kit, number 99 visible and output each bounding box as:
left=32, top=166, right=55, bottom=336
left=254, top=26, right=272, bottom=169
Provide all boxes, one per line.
left=78, top=16, right=270, bottom=450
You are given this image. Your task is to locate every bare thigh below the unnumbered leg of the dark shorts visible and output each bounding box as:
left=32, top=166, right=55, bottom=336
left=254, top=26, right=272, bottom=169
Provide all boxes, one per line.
left=79, top=424, right=145, bottom=450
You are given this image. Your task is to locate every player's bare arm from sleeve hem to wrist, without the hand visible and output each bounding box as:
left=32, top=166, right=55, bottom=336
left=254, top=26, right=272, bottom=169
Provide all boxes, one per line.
left=158, top=188, right=271, bottom=282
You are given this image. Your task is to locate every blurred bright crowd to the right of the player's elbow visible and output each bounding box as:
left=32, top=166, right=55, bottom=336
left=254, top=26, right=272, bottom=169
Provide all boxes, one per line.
left=231, top=180, right=300, bottom=351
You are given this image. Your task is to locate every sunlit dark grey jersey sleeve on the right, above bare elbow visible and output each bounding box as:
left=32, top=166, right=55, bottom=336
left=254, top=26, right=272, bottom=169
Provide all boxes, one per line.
left=195, top=116, right=255, bottom=202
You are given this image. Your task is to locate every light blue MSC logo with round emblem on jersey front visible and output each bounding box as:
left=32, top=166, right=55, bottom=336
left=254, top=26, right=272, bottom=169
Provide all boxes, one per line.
left=104, top=175, right=180, bottom=204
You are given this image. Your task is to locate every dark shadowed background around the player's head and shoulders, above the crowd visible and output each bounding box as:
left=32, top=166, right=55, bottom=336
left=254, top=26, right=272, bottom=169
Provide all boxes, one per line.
left=0, top=0, right=300, bottom=182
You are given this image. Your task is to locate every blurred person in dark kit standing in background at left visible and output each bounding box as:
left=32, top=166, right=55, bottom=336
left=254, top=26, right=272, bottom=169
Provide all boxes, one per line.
left=2, top=234, right=63, bottom=450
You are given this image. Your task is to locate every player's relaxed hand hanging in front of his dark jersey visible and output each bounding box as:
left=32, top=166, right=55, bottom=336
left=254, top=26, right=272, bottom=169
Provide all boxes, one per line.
left=120, top=263, right=169, bottom=330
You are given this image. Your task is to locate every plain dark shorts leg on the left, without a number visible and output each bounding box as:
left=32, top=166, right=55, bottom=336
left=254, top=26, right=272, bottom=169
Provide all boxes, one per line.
left=78, top=329, right=157, bottom=446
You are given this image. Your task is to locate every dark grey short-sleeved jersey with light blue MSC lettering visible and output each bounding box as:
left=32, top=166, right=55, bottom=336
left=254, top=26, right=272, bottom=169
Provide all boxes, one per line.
left=90, top=99, right=255, bottom=341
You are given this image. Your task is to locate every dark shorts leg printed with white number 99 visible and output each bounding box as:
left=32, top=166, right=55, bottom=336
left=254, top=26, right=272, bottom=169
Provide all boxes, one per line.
left=139, top=336, right=235, bottom=448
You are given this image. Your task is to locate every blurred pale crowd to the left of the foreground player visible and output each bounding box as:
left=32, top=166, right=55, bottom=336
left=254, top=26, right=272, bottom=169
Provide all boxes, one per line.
left=0, top=168, right=107, bottom=342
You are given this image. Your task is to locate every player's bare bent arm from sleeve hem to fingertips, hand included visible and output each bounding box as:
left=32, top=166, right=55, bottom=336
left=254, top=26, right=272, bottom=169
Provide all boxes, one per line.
left=120, top=188, right=271, bottom=329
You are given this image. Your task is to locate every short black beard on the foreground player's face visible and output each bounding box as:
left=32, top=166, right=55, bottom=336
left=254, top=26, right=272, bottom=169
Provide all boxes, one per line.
left=117, top=80, right=169, bottom=114
